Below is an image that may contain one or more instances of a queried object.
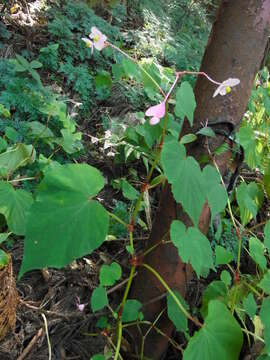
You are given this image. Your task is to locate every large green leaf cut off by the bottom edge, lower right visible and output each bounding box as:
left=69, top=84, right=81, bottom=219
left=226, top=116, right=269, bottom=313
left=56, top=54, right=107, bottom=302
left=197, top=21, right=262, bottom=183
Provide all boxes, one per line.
left=183, top=300, right=243, bottom=360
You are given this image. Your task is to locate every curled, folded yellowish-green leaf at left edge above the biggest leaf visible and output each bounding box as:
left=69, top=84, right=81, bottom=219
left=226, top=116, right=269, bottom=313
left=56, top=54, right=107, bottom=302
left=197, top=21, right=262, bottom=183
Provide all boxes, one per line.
left=0, top=144, right=36, bottom=175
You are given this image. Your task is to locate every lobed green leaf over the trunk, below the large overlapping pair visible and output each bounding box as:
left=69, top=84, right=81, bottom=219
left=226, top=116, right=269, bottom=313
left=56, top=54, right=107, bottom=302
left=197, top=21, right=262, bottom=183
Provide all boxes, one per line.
left=170, top=220, right=214, bottom=276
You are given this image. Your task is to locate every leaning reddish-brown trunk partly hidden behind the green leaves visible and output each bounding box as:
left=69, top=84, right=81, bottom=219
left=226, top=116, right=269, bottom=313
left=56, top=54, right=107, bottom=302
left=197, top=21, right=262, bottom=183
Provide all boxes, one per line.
left=127, top=0, right=270, bottom=359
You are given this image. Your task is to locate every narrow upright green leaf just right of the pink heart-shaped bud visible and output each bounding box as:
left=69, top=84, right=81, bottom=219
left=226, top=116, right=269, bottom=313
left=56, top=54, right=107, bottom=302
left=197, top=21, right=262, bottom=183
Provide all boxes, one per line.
left=174, top=81, right=196, bottom=126
